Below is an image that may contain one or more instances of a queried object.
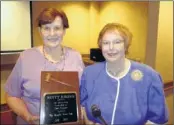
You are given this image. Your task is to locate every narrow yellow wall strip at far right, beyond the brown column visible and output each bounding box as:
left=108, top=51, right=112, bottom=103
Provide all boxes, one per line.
left=155, top=1, right=173, bottom=81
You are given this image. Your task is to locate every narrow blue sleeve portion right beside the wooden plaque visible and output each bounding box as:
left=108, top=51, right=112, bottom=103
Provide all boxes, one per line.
left=80, top=72, right=88, bottom=106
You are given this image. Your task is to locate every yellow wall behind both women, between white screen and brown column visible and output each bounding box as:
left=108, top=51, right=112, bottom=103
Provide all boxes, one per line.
left=33, top=2, right=148, bottom=61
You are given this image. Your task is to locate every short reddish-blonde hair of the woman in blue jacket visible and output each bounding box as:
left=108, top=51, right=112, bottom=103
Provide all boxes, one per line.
left=98, top=23, right=132, bottom=53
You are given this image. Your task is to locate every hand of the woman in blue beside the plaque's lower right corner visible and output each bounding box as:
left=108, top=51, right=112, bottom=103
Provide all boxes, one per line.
left=81, top=107, right=101, bottom=125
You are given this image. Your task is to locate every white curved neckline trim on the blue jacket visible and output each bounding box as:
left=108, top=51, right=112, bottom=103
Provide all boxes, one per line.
left=105, top=59, right=132, bottom=80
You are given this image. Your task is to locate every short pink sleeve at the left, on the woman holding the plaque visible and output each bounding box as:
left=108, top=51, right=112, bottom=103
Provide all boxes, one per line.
left=5, top=56, right=22, bottom=97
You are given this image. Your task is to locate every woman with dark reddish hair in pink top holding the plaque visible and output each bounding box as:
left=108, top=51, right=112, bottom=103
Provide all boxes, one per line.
left=5, top=8, right=84, bottom=124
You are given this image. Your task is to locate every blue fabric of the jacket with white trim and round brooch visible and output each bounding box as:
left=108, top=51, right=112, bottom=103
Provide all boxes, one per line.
left=80, top=61, right=168, bottom=125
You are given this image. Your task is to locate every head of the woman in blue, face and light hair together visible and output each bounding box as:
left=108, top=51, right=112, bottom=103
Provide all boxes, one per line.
left=98, top=23, right=132, bottom=62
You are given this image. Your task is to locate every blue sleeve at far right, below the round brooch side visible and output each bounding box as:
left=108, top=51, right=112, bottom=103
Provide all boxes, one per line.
left=147, top=75, right=168, bottom=124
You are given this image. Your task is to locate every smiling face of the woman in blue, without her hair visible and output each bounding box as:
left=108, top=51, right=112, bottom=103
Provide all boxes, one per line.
left=101, top=31, right=125, bottom=62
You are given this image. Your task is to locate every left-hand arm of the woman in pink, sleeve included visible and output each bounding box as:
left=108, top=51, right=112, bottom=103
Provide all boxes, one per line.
left=5, top=55, right=36, bottom=123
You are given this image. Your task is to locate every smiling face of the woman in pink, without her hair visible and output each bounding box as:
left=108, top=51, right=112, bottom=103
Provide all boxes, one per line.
left=40, top=16, right=65, bottom=47
